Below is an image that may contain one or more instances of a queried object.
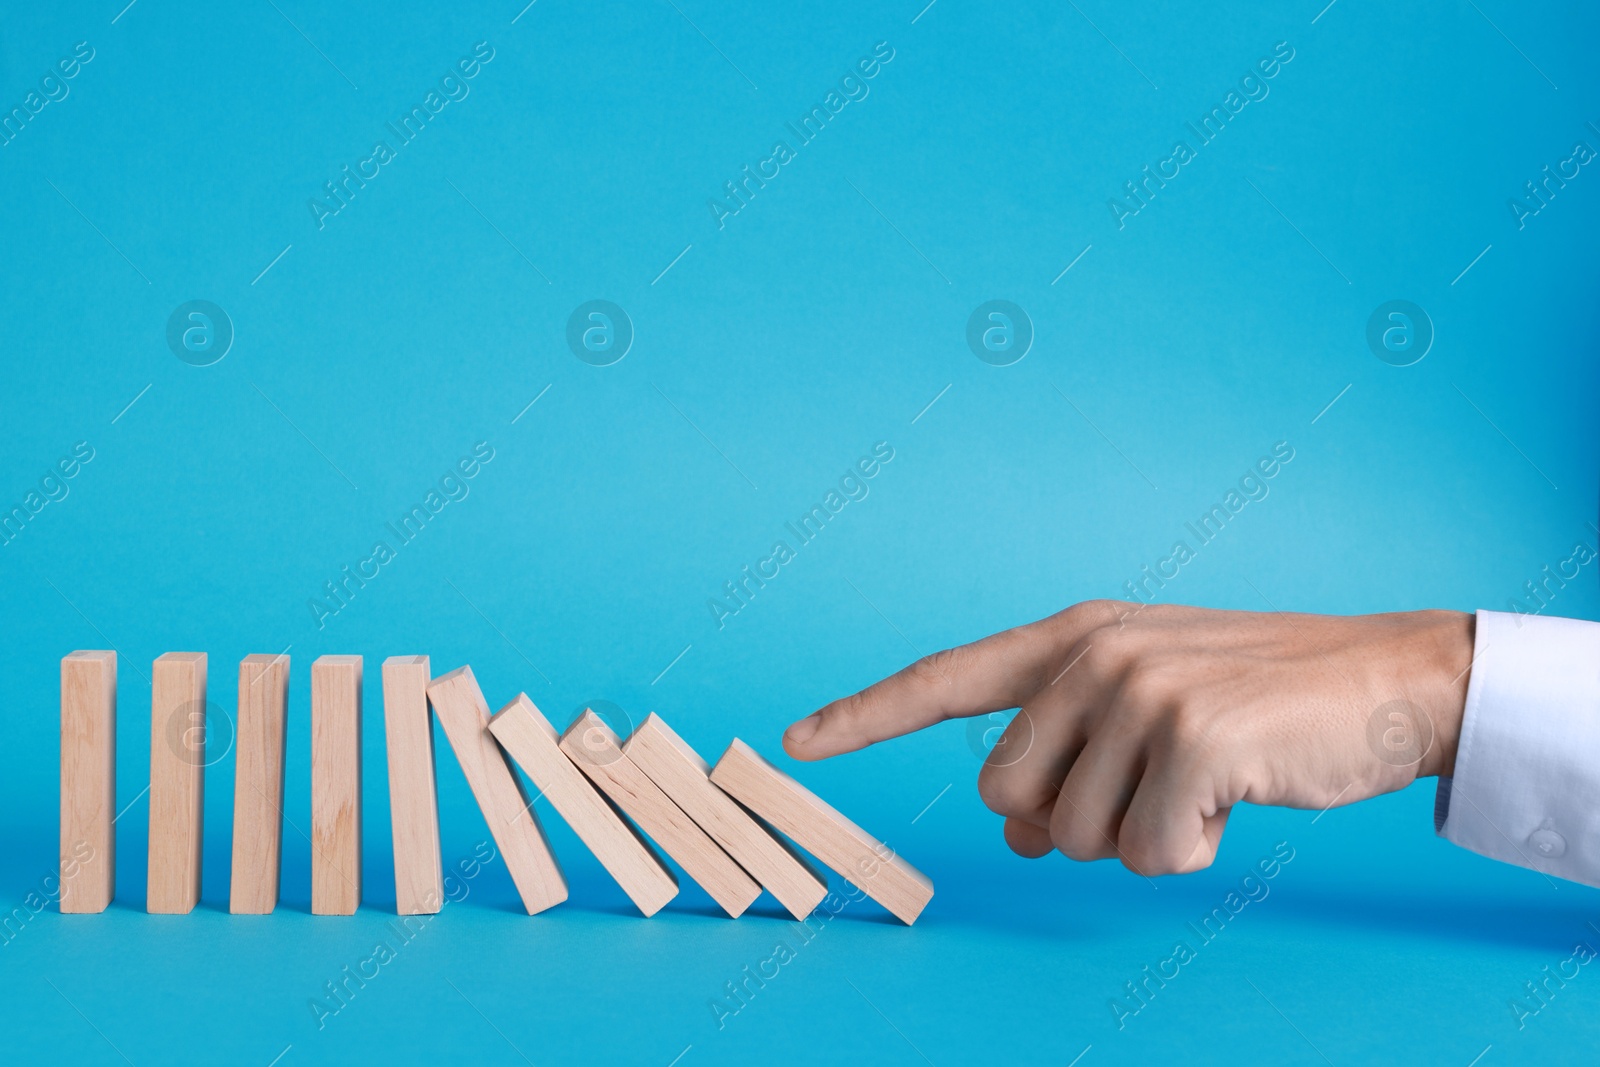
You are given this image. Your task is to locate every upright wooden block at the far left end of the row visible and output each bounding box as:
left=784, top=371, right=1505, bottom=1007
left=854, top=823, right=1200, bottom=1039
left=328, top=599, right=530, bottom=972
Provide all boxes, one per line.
left=59, top=651, right=117, bottom=913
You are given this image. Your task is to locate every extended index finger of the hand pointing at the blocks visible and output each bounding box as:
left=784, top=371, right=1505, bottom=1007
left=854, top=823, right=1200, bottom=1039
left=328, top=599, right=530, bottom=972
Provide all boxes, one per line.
left=784, top=601, right=1115, bottom=760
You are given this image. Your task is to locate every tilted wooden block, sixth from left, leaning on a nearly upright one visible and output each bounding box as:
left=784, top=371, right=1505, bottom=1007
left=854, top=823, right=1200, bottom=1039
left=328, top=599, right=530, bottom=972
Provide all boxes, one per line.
left=427, top=667, right=566, bottom=915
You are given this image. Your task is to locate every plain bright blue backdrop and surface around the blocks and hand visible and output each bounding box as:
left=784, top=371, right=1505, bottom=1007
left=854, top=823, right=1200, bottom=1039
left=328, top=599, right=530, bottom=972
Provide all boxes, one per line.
left=0, top=0, right=1600, bottom=1067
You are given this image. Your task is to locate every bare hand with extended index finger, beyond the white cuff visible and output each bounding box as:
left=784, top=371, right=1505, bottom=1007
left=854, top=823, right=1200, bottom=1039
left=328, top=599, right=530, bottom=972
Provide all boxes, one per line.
left=784, top=600, right=1474, bottom=875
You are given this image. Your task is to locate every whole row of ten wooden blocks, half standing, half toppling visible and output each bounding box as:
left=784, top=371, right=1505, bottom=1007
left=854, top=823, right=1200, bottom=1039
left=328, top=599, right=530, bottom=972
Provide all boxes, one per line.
left=61, top=651, right=933, bottom=925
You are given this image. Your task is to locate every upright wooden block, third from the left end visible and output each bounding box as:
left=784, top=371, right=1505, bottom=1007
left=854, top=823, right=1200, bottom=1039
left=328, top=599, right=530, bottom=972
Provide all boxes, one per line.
left=227, top=654, right=290, bottom=915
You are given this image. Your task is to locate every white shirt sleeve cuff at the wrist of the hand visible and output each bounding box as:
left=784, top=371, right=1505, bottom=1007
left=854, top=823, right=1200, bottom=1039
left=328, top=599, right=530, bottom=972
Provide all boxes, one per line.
left=1434, top=611, right=1600, bottom=886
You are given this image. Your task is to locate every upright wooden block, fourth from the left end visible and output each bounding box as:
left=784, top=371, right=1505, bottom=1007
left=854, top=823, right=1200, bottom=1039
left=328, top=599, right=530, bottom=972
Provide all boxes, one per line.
left=310, top=656, right=362, bottom=915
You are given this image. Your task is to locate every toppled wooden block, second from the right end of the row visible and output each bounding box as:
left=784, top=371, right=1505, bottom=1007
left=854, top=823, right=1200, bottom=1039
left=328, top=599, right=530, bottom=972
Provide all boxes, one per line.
left=622, top=713, right=827, bottom=918
